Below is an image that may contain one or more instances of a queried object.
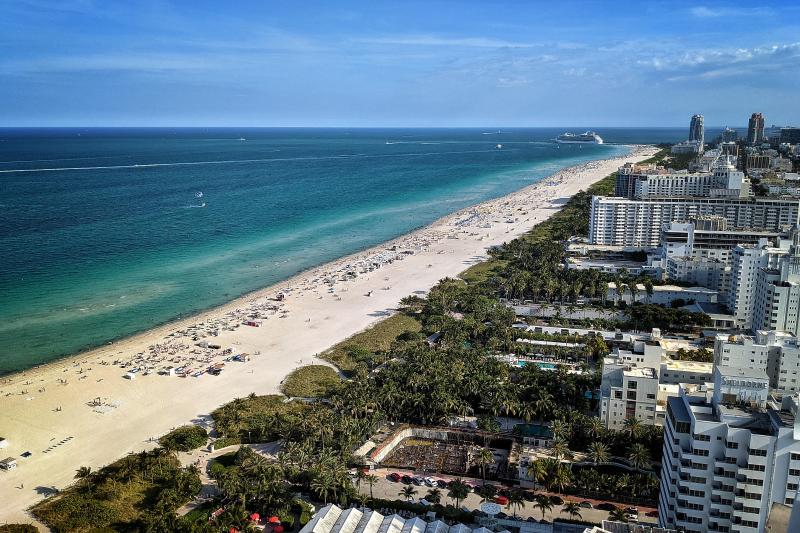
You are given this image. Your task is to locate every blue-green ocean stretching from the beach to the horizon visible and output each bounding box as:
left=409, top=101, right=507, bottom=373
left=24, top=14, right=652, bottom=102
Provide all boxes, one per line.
left=0, top=128, right=710, bottom=374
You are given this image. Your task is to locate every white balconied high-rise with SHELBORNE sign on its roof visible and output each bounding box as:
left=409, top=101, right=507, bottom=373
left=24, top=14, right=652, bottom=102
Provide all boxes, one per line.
left=658, top=366, right=800, bottom=533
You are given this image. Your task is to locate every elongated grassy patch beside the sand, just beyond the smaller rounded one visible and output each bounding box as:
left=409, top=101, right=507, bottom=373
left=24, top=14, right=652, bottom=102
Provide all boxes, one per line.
left=321, top=313, right=422, bottom=372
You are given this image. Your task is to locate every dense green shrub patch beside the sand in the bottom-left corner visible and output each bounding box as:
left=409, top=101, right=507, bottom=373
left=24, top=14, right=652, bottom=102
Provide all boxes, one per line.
left=31, top=448, right=200, bottom=532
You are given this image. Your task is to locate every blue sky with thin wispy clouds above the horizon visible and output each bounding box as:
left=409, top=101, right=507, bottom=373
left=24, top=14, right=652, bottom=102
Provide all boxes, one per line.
left=0, top=0, right=800, bottom=127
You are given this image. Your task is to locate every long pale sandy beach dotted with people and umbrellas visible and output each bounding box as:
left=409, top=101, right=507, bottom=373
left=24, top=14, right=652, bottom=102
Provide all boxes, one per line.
left=0, top=146, right=657, bottom=523
